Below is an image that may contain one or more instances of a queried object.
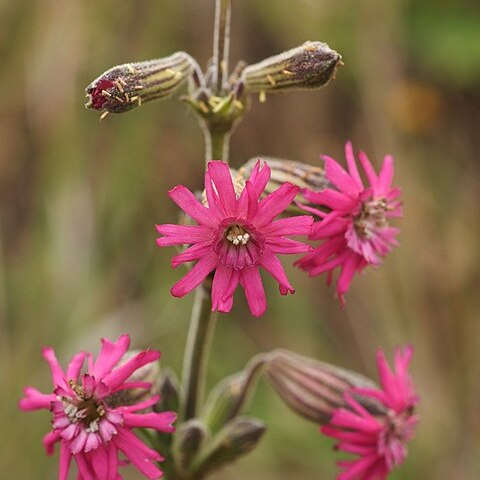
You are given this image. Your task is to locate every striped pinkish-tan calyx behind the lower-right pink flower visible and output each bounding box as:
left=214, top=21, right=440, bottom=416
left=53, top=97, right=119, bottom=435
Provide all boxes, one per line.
left=267, top=350, right=384, bottom=424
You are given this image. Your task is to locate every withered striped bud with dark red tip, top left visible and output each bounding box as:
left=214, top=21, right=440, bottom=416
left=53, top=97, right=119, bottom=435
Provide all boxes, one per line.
left=85, top=52, right=195, bottom=113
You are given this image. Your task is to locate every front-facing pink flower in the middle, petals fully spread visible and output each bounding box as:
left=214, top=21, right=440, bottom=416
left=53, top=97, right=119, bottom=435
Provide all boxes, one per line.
left=157, top=161, right=313, bottom=317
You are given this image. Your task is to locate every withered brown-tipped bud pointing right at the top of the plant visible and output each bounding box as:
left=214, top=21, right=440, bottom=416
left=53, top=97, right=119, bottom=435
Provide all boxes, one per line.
left=241, top=42, right=342, bottom=95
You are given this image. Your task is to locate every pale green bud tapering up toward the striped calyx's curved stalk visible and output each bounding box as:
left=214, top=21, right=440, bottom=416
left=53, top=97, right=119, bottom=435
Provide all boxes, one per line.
left=203, top=356, right=264, bottom=433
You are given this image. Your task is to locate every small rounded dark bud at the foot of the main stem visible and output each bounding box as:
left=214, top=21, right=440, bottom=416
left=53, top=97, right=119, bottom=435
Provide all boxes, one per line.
left=173, top=419, right=207, bottom=471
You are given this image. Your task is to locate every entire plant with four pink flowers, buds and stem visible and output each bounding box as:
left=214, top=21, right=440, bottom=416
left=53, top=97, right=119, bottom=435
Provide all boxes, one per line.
left=19, top=0, right=418, bottom=480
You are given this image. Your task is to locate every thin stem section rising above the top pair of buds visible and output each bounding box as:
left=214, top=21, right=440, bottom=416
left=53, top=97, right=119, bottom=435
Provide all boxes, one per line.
left=213, top=0, right=232, bottom=95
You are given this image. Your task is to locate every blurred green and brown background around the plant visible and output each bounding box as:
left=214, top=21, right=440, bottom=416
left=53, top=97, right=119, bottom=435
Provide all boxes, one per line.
left=0, top=0, right=480, bottom=480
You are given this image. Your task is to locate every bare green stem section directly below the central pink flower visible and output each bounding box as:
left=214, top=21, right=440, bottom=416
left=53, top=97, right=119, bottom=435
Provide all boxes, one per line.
left=182, top=286, right=217, bottom=421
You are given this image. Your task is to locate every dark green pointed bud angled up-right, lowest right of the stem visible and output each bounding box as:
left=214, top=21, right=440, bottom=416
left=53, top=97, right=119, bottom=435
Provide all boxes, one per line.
left=194, top=417, right=266, bottom=478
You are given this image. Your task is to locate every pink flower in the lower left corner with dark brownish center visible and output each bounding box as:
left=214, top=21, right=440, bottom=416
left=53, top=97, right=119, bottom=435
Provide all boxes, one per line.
left=19, top=335, right=176, bottom=480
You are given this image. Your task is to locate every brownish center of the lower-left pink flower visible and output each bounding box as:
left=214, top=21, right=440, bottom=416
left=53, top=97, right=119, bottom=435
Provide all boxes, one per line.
left=62, top=380, right=106, bottom=432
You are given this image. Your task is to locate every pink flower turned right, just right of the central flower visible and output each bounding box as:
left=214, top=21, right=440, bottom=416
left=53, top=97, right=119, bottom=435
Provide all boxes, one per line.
left=297, top=142, right=402, bottom=305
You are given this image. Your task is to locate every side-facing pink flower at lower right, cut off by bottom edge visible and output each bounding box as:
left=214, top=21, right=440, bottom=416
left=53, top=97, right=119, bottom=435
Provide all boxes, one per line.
left=321, top=346, right=418, bottom=480
